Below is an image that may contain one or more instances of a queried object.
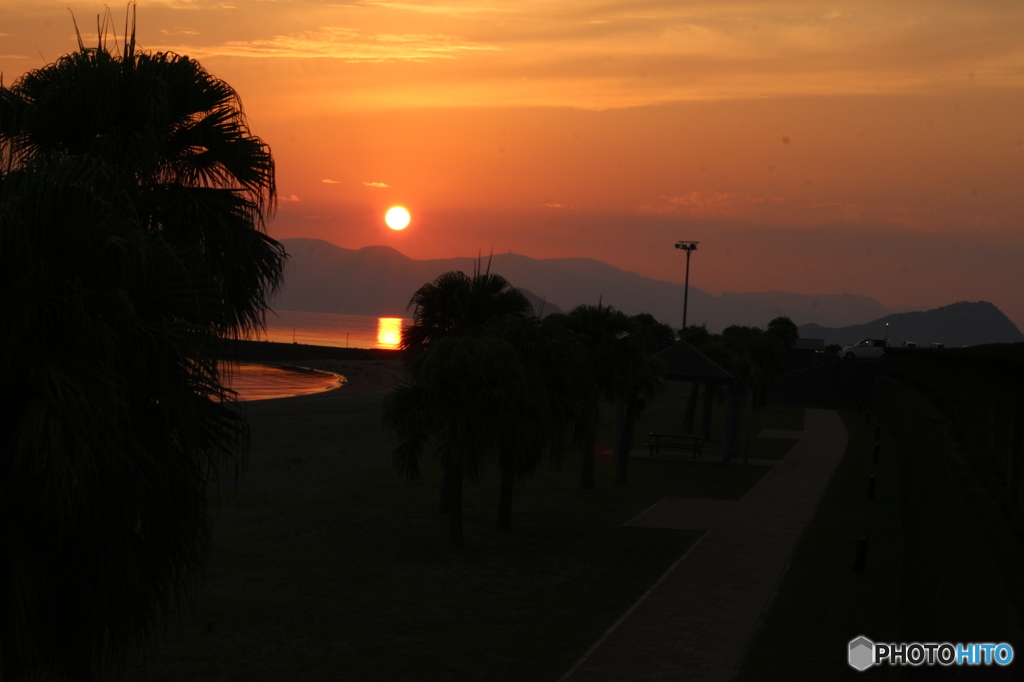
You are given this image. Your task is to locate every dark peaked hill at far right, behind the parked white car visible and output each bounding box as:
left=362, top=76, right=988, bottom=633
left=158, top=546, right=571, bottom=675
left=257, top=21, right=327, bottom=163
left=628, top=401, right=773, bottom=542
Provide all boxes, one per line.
left=800, top=301, right=1024, bottom=347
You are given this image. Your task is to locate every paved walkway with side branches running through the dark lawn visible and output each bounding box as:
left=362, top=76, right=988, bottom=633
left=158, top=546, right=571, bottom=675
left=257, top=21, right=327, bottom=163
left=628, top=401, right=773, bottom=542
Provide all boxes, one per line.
left=562, top=410, right=847, bottom=682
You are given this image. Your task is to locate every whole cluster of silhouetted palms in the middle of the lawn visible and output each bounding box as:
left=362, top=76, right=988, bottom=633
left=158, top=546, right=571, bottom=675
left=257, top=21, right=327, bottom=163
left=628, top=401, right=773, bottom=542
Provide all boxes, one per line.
left=383, top=266, right=675, bottom=546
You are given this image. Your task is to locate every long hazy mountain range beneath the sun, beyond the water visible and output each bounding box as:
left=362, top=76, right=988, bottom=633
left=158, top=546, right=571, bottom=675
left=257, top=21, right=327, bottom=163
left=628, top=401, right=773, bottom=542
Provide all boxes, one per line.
left=273, top=239, right=905, bottom=332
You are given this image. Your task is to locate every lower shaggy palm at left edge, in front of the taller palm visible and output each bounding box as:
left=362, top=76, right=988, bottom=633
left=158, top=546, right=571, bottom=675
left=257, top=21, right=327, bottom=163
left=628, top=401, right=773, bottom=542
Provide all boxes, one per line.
left=0, top=156, right=246, bottom=681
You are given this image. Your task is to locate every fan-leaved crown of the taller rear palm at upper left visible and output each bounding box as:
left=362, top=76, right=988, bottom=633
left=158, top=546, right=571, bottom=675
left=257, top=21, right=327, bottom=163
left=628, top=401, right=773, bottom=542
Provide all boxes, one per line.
left=0, top=29, right=285, bottom=334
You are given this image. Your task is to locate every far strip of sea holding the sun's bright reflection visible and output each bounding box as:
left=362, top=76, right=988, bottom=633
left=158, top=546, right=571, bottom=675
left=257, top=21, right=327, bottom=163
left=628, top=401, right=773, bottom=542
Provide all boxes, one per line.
left=260, top=310, right=413, bottom=348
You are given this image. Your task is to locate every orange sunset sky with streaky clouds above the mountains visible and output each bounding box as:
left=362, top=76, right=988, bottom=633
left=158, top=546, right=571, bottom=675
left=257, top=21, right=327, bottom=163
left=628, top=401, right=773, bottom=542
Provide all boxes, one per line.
left=0, top=0, right=1024, bottom=327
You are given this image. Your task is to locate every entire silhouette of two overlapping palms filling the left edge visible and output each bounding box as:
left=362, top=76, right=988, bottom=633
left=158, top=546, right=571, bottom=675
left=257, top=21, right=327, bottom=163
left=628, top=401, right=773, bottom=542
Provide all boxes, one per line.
left=0, top=23, right=285, bottom=680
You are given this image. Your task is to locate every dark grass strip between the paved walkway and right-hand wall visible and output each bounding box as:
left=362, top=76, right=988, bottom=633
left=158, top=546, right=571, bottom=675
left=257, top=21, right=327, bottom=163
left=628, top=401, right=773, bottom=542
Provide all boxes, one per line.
left=736, top=412, right=903, bottom=682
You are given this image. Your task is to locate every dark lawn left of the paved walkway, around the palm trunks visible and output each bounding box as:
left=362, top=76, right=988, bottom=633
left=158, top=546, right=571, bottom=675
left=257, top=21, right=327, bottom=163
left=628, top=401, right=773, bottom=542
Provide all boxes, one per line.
left=112, top=374, right=802, bottom=682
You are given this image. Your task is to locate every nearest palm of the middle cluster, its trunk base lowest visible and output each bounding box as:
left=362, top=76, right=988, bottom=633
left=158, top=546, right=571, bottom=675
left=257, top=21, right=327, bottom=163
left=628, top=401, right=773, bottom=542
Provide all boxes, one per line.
left=383, top=335, right=528, bottom=547
